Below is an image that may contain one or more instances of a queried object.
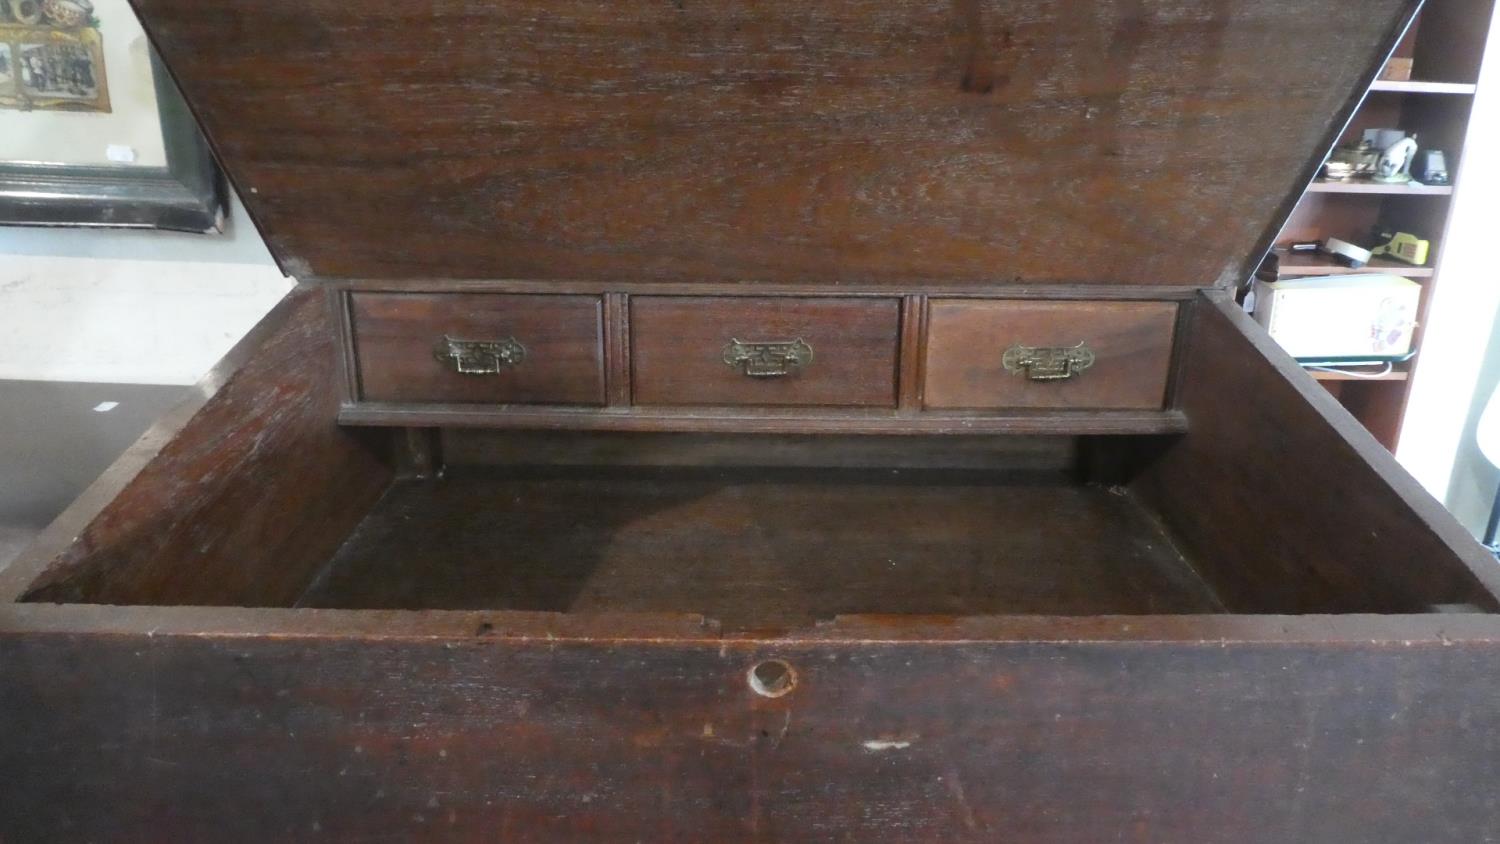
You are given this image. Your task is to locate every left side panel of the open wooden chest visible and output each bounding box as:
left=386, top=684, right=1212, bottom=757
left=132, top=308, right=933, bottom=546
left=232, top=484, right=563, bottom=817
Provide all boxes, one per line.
left=0, top=288, right=392, bottom=606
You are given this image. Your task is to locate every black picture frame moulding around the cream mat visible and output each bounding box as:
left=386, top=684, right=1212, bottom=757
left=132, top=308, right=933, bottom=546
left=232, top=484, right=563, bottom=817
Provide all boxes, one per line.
left=0, top=49, right=228, bottom=234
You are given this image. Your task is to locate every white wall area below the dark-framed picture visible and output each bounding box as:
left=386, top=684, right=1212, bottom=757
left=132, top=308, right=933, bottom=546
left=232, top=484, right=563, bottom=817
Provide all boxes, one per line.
left=0, top=193, right=291, bottom=384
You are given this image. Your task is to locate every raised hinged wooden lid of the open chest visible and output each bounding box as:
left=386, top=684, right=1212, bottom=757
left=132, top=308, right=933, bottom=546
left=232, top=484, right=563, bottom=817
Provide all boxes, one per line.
left=135, top=0, right=1416, bottom=286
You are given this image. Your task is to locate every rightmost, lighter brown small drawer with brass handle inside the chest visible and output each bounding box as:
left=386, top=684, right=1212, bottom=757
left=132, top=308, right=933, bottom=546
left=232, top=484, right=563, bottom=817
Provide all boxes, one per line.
left=923, top=300, right=1178, bottom=409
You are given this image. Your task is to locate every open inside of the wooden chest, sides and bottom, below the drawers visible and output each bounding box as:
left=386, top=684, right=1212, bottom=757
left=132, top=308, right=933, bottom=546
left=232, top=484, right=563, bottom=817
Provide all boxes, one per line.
left=6, top=294, right=1496, bottom=630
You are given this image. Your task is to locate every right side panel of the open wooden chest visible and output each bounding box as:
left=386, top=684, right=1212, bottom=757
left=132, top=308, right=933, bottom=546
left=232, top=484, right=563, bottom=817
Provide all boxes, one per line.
left=1136, top=298, right=1500, bottom=613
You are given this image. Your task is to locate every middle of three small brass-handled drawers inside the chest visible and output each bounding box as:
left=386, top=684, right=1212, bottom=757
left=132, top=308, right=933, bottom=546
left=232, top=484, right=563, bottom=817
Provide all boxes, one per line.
left=630, top=297, right=900, bottom=408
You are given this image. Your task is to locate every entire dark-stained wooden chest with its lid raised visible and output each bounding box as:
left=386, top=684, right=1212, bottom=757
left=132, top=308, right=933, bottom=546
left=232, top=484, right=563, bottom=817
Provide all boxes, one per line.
left=0, top=0, right=1500, bottom=844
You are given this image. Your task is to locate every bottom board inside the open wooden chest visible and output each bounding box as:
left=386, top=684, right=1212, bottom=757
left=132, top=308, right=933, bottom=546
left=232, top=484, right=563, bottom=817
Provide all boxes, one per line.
left=299, top=466, right=1218, bottom=628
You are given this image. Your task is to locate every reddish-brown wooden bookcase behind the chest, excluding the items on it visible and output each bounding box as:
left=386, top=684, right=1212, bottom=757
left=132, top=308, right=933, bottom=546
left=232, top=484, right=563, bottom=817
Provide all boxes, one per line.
left=1277, top=0, right=1496, bottom=450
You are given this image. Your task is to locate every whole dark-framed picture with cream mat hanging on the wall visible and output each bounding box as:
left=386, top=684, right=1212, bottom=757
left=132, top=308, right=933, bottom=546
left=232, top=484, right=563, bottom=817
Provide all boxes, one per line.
left=0, top=0, right=225, bottom=232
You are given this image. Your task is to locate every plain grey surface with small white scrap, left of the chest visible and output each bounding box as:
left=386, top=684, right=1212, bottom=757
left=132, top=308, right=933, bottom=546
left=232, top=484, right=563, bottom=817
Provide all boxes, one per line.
left=0, top=381, right=191, bottom=568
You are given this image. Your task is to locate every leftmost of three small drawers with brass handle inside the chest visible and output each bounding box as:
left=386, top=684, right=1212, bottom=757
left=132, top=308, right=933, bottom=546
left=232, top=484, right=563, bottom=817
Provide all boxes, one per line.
left=351, top=294, right=605, bottom=405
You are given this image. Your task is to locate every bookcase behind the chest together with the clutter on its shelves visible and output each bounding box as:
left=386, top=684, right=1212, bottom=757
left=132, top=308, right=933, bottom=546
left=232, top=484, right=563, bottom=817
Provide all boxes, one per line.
left=1266, top=8, right=1494, bottom=450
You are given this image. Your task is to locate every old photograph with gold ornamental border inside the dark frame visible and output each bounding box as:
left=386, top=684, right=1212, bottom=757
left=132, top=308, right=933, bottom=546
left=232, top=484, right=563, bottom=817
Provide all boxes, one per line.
left=0, top=0, right=108, bottom=112
